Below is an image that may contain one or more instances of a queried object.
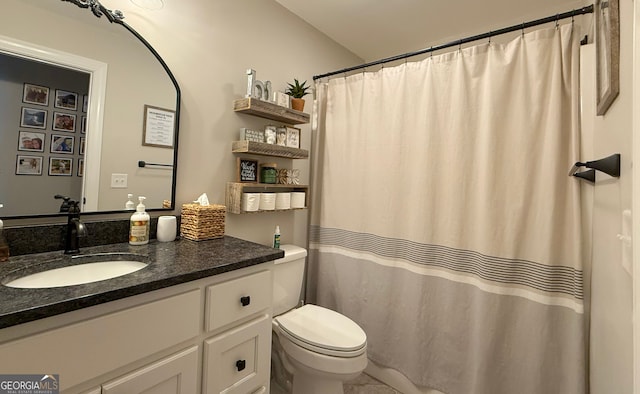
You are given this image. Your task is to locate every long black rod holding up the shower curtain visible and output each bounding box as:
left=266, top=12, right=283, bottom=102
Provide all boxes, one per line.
left=313, top=4, right=593, bottom=81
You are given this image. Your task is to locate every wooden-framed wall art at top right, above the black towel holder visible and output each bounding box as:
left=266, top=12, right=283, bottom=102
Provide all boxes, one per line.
left=595, top=0, right=620, bottom=115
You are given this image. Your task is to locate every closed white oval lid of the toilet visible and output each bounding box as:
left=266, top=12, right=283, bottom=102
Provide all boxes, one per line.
left=275, top=304, right=367, bottom=352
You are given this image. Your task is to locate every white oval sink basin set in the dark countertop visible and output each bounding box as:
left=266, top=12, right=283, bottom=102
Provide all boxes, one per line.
left=4, top=260, right=147, bottom=289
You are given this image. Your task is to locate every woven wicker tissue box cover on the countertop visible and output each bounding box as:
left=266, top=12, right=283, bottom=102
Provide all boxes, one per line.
left=180, top=204, right=227, bottom=241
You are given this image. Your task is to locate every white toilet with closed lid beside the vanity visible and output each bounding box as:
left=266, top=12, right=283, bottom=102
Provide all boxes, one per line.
left=272, top=245, right=367, bottom=394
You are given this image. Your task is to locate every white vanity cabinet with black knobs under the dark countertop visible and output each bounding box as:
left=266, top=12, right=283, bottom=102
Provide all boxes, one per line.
left=0, top=262, right=273, bottom=394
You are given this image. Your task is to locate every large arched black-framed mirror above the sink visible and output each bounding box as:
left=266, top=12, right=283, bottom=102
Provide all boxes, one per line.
left=0, top=0, right=180, bottom=218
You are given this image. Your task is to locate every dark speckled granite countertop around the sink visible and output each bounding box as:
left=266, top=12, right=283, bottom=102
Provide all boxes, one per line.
left=0, top=236, right=284, bottom=328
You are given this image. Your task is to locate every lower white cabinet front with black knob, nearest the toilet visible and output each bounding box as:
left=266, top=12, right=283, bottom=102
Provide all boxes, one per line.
left=202, top=315, right=271, bottom=394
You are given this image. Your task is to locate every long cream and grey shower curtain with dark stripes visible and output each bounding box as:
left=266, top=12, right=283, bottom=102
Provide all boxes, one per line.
left=307, top=25, right=586, bottom=394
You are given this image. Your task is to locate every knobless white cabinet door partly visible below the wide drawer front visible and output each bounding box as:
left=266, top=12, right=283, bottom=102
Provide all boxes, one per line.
left=102, top=346, right=198, bottom=394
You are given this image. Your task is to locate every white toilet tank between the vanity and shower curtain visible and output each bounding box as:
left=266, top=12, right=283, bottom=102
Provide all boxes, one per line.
left=272, top=245, right=307, bottom=316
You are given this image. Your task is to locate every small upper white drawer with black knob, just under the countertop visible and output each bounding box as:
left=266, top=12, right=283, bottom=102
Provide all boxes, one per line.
left=205, top=271, right=273, bottom=331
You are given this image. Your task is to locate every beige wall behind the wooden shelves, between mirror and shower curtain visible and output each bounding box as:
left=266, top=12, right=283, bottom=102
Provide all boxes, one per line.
left=103, top=0, right=361, bottom=246
